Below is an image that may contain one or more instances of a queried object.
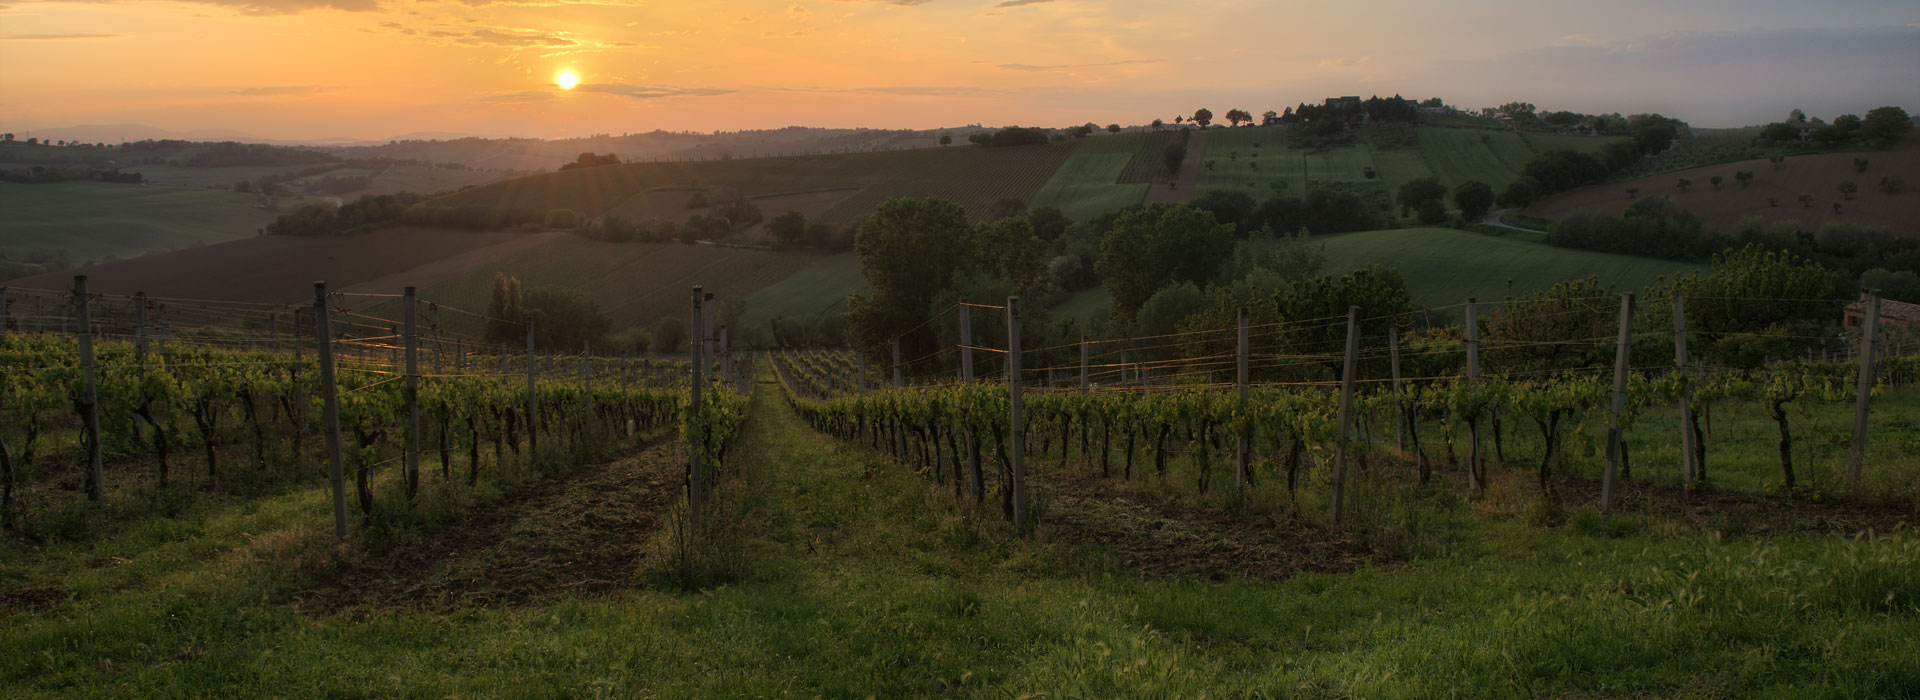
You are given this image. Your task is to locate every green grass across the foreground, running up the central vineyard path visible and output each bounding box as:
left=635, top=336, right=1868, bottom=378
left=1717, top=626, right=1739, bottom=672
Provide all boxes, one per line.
left=0, top=375, right=1920, bottom=698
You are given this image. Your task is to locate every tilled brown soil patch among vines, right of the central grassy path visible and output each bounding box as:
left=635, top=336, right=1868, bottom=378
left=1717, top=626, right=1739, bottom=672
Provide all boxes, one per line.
left=1039, top=472, right=1379, bottom=581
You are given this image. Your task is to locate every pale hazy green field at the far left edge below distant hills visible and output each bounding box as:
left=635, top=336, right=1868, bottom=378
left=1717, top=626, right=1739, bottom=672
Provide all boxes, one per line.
left=0, top=182, right=275, bottom=263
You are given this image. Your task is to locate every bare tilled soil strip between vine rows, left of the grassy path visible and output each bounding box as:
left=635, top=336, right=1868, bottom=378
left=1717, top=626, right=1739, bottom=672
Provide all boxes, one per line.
left=296, top=439, right=685, bottom=614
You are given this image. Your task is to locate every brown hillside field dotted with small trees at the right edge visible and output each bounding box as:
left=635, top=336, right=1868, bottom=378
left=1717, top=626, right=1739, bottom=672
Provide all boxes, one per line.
left=1524, top=138, right=1920, bottom=236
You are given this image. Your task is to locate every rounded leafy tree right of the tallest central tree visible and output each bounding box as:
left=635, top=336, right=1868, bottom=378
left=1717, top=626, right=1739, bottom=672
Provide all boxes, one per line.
left=1094, top=203, right=1235, bottom=326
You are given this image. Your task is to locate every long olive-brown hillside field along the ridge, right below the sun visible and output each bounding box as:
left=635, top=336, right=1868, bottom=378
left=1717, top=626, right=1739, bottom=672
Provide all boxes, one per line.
left=436, top=142, right=1079, bottom=226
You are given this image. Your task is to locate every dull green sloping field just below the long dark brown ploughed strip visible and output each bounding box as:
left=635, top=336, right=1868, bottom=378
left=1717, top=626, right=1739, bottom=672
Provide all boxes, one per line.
left=367, top=236, right=820, bottom=334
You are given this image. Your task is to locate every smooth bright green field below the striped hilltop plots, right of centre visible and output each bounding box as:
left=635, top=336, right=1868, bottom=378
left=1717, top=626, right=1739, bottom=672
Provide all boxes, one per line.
left=1317, top=228, right=1695, bottom=307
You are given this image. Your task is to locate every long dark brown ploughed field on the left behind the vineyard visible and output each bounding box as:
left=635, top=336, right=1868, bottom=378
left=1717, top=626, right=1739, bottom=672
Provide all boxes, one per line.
left=8, top=226, right=541, bottom=303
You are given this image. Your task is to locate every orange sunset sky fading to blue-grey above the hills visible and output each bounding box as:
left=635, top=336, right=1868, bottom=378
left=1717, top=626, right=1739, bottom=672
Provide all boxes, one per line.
left=0, top=0, right=1920, bottom=140
